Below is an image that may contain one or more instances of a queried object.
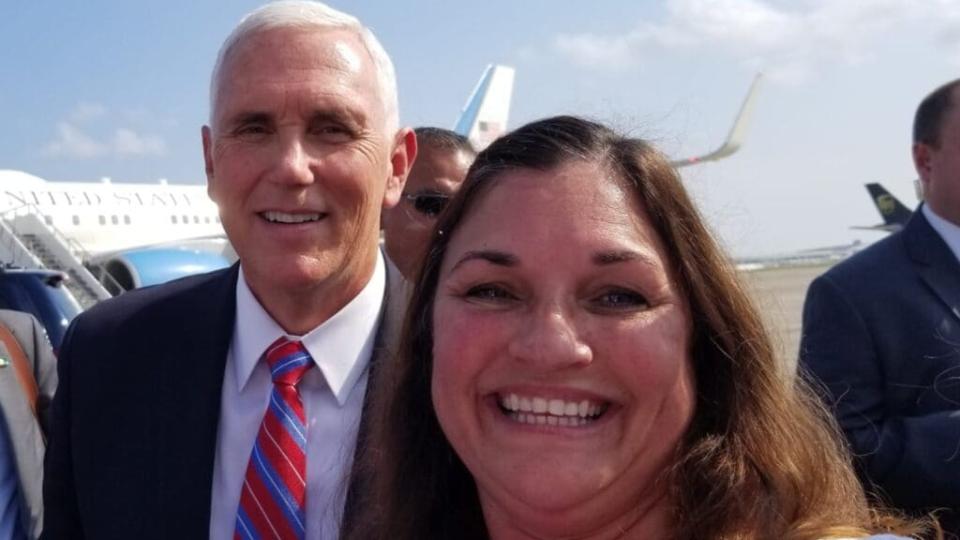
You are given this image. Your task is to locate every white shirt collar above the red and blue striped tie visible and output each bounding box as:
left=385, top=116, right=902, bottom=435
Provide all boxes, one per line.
left=231, top=250, right=386, bottom=406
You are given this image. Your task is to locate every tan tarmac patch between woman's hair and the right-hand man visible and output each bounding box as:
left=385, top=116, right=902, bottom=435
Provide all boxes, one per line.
left=742, top=261, right=836, bottom=373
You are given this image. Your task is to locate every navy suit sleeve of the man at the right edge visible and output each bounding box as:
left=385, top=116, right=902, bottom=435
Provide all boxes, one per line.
left=800, top=276, right=960, bottom=508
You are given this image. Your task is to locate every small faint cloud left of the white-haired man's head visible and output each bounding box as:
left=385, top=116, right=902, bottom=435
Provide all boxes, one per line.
left=41, top=102, right=167, bottom=159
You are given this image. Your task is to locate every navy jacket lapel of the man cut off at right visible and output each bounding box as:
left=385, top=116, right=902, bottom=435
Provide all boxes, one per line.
left=903, top=209, right=960, bottom=320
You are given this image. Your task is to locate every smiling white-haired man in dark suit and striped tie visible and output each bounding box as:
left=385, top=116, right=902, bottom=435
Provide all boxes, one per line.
left=44, top=1, right=416, bottom=540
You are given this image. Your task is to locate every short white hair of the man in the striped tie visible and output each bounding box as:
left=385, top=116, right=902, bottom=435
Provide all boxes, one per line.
left=210, top=0, right=400, bottom=133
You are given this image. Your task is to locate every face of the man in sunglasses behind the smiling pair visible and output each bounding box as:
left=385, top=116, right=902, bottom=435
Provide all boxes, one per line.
left=383, top=146, right=473, bottom=280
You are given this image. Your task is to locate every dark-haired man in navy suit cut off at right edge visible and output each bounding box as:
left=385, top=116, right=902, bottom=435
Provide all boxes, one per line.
left=800, top=80, right=960, bottom=532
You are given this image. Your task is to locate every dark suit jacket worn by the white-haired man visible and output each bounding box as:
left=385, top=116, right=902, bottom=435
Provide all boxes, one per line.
left=44, top=265, right=404, bottom=540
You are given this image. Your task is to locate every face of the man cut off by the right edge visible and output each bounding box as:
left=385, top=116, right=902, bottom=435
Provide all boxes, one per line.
left=913, top=88, right=960, bottom=225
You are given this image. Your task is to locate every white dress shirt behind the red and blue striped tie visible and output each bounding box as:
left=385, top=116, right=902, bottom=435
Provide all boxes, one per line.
left=210, top=255, right=386, bottom=540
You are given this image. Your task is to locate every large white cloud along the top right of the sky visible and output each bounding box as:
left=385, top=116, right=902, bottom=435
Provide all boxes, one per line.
left=553, top=0, right=960, bottom=81
